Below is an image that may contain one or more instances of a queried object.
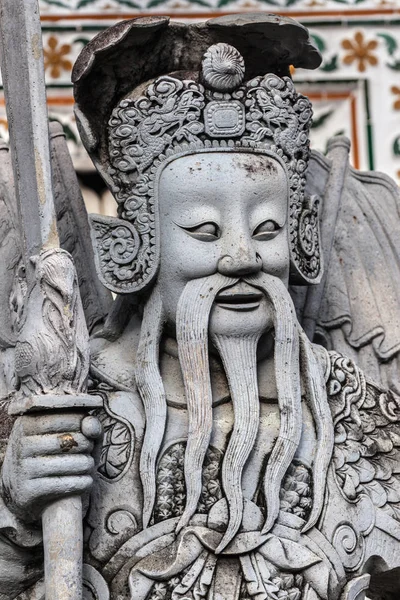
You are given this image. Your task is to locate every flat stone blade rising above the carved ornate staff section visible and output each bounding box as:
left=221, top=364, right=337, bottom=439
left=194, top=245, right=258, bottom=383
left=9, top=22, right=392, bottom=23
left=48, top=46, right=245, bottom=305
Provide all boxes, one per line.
left=0, top=0, right=59, bottom=278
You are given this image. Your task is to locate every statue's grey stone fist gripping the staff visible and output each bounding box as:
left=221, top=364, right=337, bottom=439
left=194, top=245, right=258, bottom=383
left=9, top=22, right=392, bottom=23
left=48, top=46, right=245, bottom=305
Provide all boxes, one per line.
left=2, top=412, right=101, bottom=522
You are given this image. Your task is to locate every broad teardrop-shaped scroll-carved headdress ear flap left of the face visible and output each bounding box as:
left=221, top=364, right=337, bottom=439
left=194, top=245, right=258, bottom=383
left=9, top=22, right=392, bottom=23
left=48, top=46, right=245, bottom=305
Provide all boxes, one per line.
left=89, top=215, right=157, bottom=294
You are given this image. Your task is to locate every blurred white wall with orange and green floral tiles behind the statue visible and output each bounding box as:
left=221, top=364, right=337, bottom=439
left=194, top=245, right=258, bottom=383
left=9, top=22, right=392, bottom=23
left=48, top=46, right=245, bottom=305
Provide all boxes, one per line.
left=0, top=0, right=400, bottom=214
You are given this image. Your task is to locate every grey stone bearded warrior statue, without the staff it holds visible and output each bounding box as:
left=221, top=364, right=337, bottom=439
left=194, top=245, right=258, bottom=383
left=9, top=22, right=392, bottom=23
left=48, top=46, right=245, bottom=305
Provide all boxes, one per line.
left=0, top=9, right=400, bottom=600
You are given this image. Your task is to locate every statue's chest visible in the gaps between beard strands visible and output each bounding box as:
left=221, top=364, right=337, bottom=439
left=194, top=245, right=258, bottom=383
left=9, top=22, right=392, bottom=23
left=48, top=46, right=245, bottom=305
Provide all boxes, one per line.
left=152, top=402, right=312, bottom=523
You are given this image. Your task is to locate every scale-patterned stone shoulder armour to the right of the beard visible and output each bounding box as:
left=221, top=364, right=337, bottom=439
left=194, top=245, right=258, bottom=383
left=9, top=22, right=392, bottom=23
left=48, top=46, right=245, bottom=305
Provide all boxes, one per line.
left=327, top=352, right=400, bottom=520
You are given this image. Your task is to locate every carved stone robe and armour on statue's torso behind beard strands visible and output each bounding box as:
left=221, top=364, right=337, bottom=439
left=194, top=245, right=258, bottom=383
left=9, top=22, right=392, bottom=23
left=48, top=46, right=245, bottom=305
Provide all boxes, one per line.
left=0, top=318, right=400, bottom=600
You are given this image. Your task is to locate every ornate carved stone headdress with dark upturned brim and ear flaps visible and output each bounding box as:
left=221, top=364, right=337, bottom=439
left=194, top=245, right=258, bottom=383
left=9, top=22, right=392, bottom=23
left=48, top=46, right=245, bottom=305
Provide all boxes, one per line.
left=75, top=15, right=322, bottom=293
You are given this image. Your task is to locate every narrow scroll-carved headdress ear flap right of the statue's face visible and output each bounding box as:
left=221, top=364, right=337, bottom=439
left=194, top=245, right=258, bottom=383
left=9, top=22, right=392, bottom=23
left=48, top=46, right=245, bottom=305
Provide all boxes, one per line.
left=290, top=195, right=323, bottom=285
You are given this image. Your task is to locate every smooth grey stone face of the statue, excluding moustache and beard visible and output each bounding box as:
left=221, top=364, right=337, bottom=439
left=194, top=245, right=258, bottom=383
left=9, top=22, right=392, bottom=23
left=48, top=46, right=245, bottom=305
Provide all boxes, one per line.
left=158, top=152, right=289, bottom=334
